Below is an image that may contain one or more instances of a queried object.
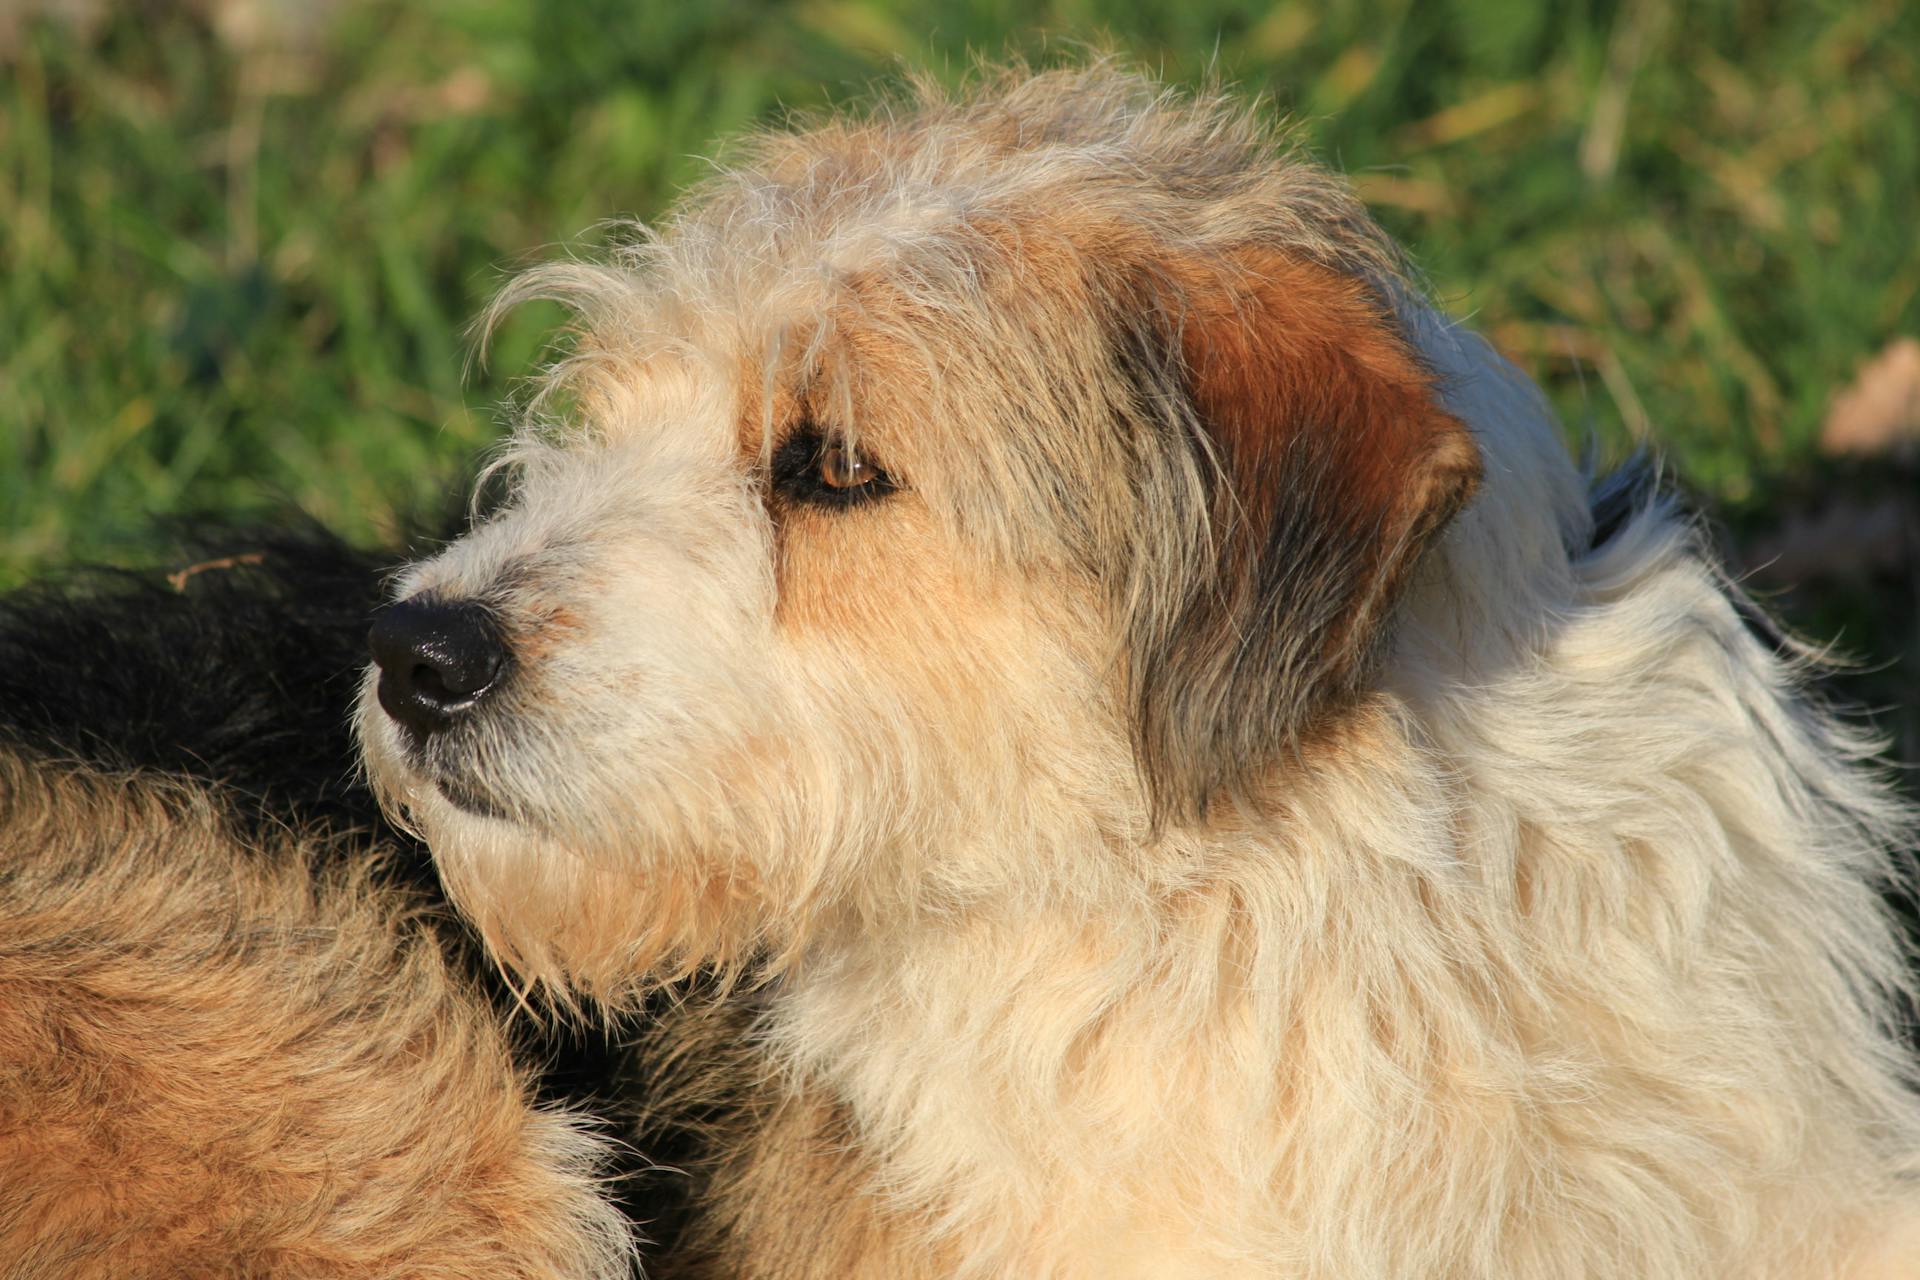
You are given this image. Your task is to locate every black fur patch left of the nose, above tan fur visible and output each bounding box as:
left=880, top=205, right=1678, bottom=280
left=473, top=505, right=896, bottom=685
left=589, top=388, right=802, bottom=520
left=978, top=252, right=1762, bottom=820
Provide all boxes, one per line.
left=0, top=530, right=401, bottom=844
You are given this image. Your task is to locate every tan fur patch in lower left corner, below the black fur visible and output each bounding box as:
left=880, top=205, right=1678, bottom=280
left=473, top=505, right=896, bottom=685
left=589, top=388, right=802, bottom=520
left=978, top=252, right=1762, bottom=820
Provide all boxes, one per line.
left=0, top=754, right=628, bottom=1280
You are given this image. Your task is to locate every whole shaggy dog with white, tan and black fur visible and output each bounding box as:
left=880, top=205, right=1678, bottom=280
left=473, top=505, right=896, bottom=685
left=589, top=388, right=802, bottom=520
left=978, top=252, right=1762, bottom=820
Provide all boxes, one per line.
left=0, top=67, right=1920, bottom=1280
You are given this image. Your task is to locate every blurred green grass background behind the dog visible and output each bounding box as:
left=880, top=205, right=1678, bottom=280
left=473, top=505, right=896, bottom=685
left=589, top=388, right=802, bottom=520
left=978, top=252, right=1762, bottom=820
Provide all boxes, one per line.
left=0, top=0, right=1920, bottom=760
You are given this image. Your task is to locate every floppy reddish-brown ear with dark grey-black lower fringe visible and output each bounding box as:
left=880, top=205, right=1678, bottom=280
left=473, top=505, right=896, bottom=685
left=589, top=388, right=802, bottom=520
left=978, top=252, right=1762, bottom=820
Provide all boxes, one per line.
left=1127, top=249, right=1480, bottom=821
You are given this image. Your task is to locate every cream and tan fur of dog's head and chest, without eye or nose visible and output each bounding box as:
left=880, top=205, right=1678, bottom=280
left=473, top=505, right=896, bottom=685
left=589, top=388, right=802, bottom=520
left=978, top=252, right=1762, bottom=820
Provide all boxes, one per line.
left=359, top=65, right=1920, bottom=1280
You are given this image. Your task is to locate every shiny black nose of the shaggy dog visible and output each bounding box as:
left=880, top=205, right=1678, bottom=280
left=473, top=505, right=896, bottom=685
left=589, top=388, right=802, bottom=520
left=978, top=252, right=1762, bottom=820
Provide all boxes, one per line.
left=367, top=595, right=507, bottom=737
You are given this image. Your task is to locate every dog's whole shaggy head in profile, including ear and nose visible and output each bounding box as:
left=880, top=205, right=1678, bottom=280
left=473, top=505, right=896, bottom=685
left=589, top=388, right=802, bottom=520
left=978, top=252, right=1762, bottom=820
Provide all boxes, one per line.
left=359, top=77, right=1478, bottom=994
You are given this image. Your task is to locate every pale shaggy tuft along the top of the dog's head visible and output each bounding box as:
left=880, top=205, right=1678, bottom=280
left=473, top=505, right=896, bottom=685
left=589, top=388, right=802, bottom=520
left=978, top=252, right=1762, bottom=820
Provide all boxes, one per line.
left=649, top=63, right=1402, bottom=322
